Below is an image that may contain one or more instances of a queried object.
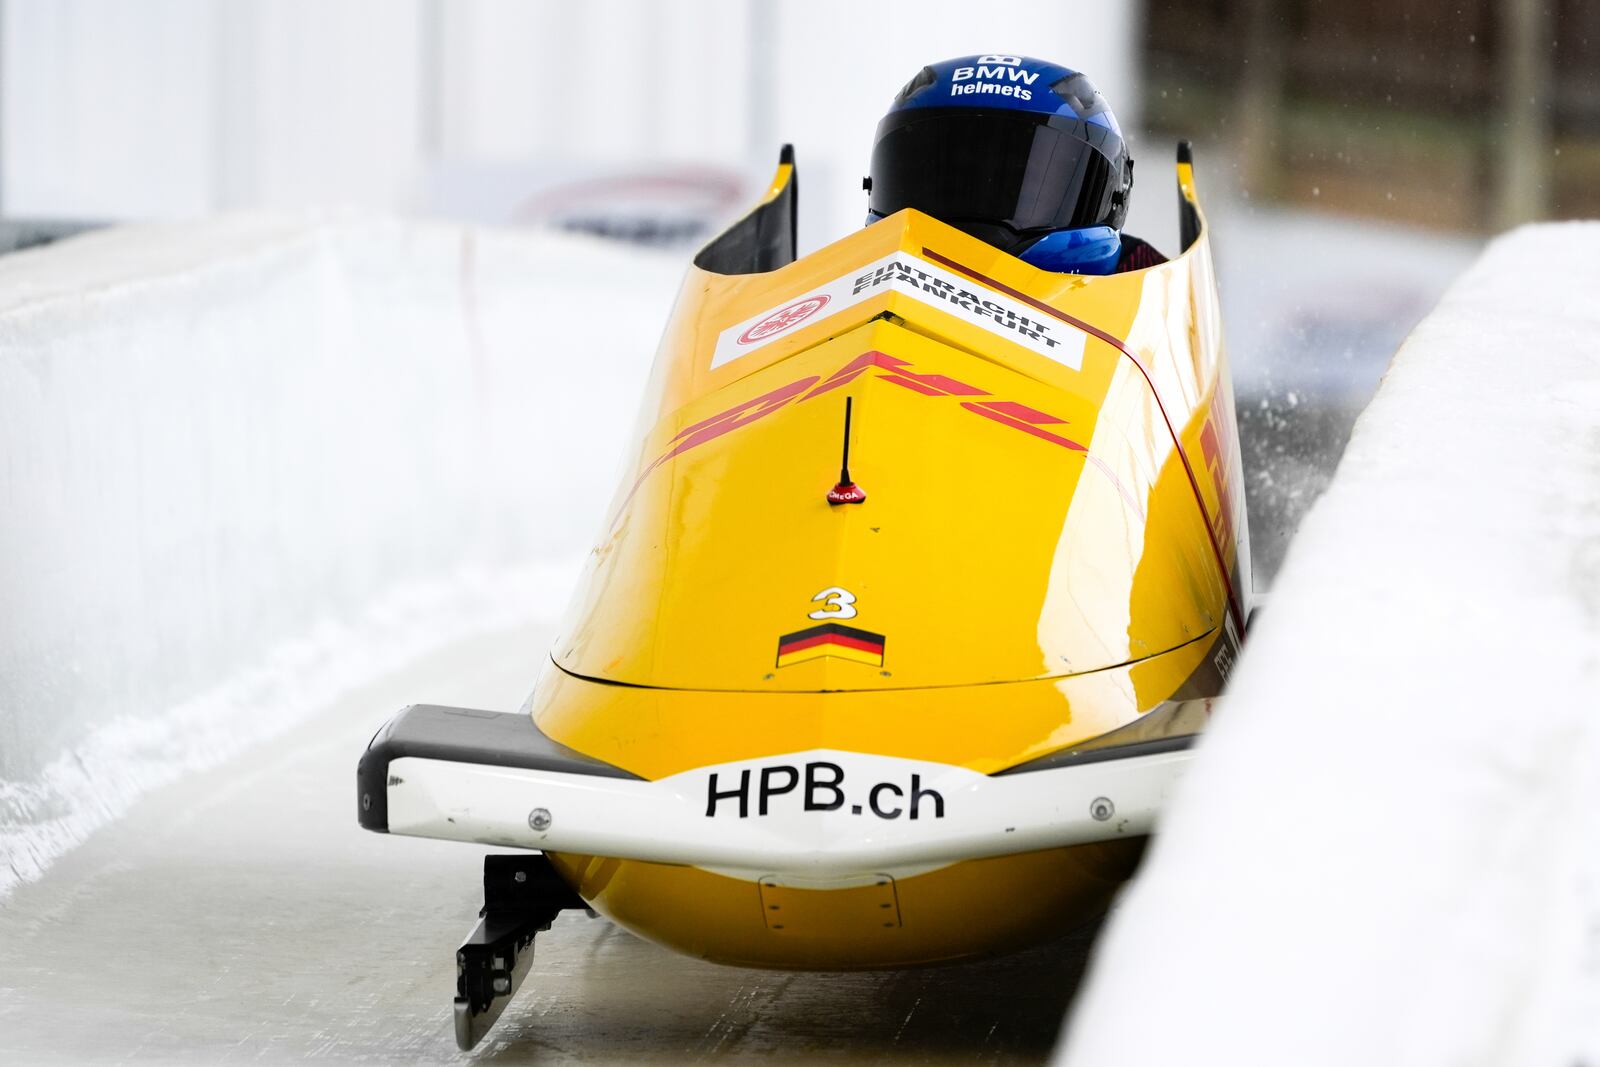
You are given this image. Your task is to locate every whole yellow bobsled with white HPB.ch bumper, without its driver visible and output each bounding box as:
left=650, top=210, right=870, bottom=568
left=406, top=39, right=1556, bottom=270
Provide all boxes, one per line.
left=358, top=137, right=1250, bottom=1048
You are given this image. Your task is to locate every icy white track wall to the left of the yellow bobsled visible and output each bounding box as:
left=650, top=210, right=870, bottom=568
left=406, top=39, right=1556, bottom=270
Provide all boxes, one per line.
left=0, top=219, right=683, bottom=897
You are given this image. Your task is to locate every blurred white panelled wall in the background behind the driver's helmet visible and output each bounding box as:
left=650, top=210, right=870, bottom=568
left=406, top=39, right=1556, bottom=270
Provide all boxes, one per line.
left=0, top=0, right=1145, bottom=248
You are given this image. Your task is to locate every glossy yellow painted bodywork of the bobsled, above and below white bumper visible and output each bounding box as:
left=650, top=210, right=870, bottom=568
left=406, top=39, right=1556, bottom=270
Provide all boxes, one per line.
left=530, top=147, right=1248, bottom=968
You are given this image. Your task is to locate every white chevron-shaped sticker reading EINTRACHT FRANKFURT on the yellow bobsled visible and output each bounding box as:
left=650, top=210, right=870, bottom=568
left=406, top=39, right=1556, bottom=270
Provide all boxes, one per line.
left=710, top=251, right=1088, bottom=370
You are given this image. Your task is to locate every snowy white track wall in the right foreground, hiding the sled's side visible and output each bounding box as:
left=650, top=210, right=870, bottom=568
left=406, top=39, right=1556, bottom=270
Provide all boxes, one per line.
left=1061, top=222, right=1600, bottom=1067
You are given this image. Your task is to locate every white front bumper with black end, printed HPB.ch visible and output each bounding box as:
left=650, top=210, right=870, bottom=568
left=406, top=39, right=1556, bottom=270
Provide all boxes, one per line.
left=357, top=704, right=1194, bottom=878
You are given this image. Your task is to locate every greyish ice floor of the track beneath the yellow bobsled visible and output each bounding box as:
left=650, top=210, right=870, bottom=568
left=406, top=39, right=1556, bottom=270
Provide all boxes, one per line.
left=0, top=627, right=1091, bottom=1064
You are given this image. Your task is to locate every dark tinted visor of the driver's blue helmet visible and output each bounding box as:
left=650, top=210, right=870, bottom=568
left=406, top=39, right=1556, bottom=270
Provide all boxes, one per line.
left=867, top=107, right=1122, bottom=235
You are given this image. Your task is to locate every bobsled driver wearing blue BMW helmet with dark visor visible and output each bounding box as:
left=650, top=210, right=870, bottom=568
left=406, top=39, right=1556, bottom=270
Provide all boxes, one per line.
left=866, top=56, right=1166, bottom=274
